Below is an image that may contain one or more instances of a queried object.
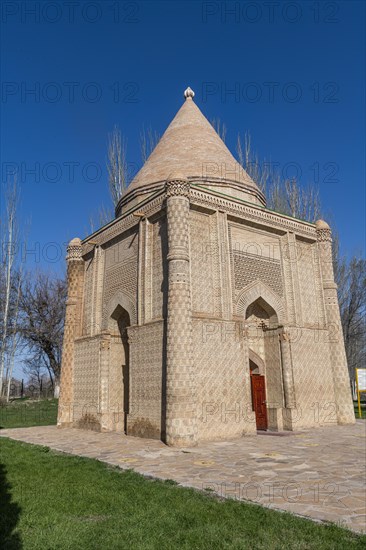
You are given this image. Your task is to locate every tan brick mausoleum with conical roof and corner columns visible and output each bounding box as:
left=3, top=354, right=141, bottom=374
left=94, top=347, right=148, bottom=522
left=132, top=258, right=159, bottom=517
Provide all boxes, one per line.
left=58, top=88, right=354, bottom=446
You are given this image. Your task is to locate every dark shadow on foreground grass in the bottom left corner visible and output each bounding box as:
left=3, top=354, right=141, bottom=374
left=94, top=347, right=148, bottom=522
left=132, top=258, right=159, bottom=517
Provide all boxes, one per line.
left=0, top=463, right=22, bottom=550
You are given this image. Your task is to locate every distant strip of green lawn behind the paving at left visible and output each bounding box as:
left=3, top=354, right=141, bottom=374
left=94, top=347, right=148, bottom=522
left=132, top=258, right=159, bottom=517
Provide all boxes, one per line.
left=0, top=399, right=58, bottom=429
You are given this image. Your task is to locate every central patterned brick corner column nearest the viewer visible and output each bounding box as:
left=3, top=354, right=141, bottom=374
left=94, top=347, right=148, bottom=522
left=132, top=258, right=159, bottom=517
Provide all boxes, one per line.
left=166, top=175, right=197, bottom=447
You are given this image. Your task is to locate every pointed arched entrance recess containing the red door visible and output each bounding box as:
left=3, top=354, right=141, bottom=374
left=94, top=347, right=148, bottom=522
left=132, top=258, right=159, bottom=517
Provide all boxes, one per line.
left=245, top=297, right=284, bottom=430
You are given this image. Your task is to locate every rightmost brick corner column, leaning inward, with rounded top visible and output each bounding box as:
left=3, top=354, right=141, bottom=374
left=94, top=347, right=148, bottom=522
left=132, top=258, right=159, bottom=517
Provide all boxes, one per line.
left=316, top=220, right=355, bottom=424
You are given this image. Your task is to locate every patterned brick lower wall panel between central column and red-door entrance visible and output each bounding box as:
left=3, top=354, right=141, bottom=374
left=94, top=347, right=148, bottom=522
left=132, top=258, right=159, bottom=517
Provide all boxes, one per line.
left=193, top=318, right=256, bottom=441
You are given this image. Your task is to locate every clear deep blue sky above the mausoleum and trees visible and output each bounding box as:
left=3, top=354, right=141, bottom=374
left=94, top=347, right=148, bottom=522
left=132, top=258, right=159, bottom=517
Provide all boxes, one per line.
left=1, top=0, right=365, bottom=278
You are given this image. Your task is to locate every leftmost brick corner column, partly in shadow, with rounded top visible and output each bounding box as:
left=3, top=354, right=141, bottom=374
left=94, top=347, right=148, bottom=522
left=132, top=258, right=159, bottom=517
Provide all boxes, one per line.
left=57, top=238, right=84, bottom=427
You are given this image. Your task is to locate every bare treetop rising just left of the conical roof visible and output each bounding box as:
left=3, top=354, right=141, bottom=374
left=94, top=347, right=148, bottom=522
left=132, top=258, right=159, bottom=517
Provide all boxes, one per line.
left=107, top=126, right=129, bottom=206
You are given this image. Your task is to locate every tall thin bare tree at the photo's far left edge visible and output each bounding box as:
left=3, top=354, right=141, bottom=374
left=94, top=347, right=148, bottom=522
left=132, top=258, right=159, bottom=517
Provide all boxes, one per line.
left=0, top=179, right=19, bottom=397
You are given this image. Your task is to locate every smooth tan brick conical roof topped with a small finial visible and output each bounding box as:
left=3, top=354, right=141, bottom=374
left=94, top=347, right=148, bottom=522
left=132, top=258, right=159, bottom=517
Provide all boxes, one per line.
left=125, top=88, right=260, bottom=195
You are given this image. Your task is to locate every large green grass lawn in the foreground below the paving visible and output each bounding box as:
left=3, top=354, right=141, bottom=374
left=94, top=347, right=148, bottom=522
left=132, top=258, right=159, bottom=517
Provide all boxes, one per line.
left=0, top=438, right=366, bottom=550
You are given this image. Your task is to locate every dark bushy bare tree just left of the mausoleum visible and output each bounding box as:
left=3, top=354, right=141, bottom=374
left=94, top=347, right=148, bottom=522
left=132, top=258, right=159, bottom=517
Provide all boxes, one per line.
left=19, top=273, right=67, bottom=397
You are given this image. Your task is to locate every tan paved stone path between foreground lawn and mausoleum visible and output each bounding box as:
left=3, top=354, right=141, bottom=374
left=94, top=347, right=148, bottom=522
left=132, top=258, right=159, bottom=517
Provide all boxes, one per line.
left=0, top=420, right=366, bottom=532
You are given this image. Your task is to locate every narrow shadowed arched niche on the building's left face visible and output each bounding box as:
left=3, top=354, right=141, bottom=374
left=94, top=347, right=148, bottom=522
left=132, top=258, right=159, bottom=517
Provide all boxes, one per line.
left=108, top=305, right=131, bottom=434
